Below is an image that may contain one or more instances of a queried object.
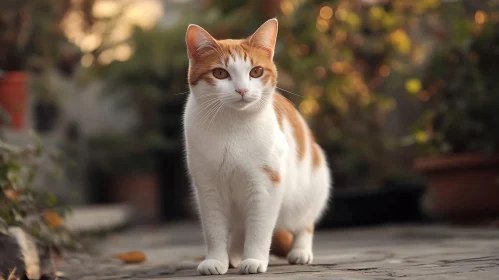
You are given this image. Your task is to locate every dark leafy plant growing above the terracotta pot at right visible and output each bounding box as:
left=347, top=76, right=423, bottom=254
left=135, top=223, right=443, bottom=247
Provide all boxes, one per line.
left=408, top=10, right=499, bottom=155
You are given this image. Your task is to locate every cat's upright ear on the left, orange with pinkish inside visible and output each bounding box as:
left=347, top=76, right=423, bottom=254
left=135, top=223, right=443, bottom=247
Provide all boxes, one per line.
left=185, top=24, right=218, bottom=59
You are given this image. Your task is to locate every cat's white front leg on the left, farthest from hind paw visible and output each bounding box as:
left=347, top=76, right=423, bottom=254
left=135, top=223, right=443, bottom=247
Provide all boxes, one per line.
left=197, top=185, right=229, bottom=275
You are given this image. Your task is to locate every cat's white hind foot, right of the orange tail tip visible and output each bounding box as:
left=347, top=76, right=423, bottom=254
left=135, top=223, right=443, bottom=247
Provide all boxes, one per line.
left=288, top=225, right=314, bottom=264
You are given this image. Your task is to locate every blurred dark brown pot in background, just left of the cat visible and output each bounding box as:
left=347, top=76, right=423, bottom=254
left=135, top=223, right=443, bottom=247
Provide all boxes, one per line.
left=110, top=173, right=160, bottom=222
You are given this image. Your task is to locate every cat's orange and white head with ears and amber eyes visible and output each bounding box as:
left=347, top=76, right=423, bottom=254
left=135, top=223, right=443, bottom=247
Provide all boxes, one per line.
left=186, top=19, right=277, bottom=110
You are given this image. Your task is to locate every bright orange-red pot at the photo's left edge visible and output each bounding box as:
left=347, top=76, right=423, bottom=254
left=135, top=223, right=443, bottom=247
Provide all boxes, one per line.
left=0, top=72, right=27, bottom=129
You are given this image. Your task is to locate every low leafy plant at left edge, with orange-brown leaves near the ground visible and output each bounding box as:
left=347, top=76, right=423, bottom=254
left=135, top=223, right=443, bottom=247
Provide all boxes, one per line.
left=0, top=133, right=79, bottom=252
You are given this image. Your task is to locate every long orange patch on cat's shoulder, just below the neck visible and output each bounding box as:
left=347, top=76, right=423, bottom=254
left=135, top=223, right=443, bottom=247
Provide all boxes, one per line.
left=274, top=93, right=306, bottom=160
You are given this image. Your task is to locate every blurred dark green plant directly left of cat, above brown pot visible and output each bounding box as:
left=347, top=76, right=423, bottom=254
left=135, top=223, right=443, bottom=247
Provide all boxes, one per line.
left=82, top=17, right=197, bottom=175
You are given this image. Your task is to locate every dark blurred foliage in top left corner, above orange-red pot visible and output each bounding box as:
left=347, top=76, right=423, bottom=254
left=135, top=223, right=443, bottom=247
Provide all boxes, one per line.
left=0, top=0, right=83, bottom=72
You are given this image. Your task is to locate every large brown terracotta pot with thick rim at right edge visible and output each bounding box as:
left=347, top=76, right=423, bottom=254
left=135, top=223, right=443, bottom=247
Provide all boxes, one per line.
left=415, top=154, right=499, bottom=223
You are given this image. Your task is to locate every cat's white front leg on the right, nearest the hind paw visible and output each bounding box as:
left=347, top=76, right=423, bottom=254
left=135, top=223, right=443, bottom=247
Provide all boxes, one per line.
left=239, top=180, right=282, bottom=274
